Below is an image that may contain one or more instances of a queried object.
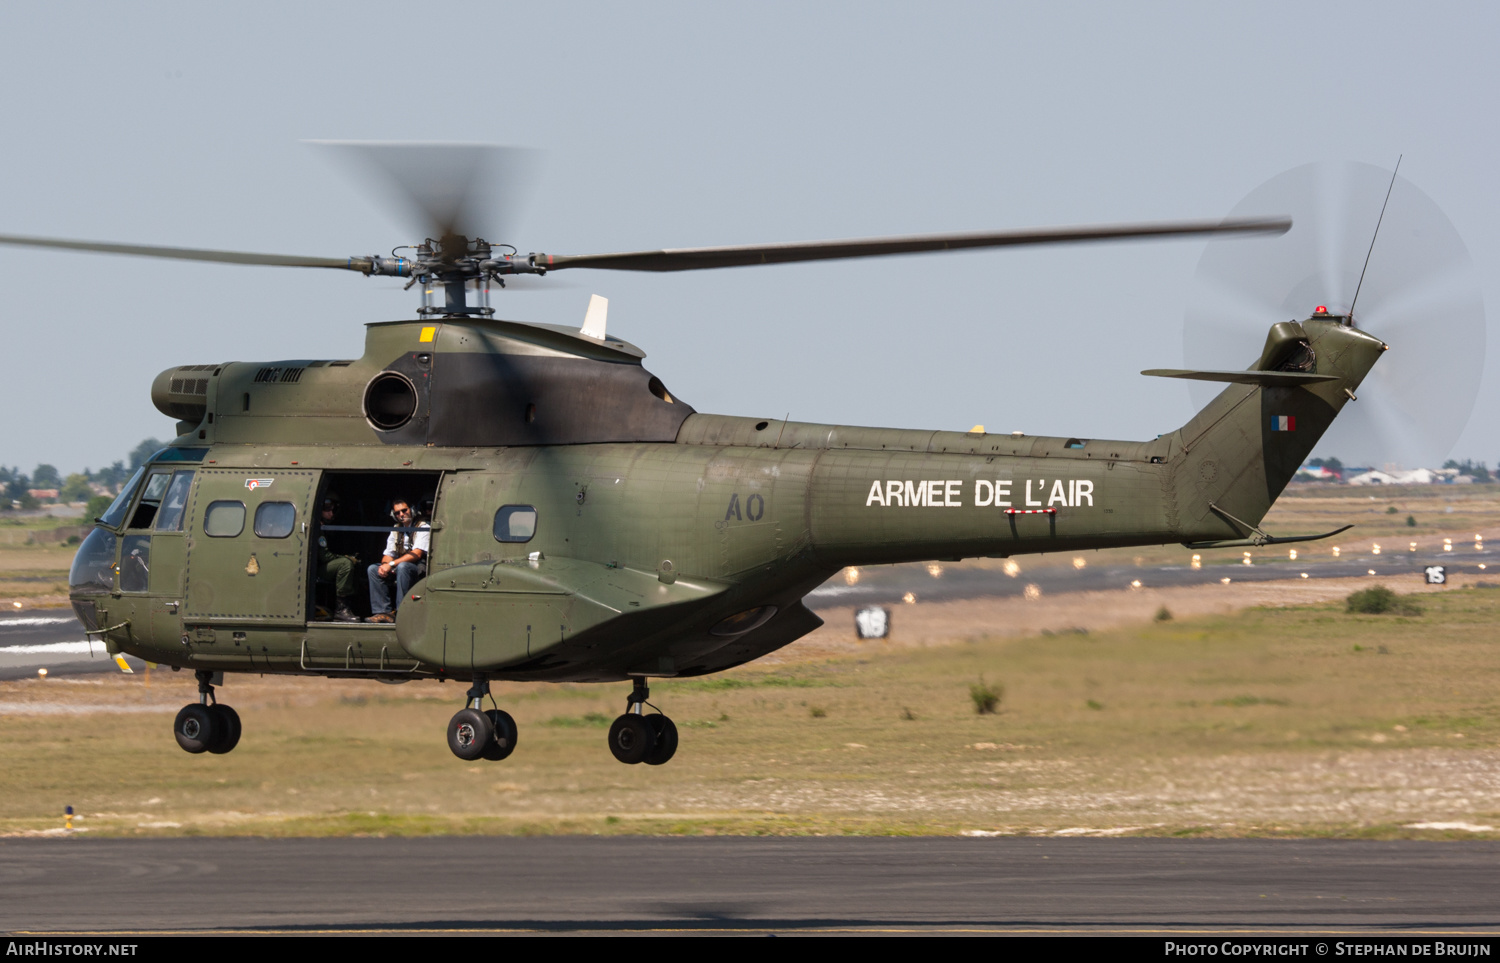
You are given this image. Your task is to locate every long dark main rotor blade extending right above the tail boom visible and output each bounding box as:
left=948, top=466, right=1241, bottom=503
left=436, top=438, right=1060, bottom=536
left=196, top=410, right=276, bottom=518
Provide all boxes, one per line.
left=537, top=218, right=1292, bottom=272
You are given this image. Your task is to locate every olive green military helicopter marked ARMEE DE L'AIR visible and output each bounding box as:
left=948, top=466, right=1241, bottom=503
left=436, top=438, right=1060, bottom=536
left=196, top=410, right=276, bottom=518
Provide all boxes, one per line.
left=0, top=146, right=1388, bottom=765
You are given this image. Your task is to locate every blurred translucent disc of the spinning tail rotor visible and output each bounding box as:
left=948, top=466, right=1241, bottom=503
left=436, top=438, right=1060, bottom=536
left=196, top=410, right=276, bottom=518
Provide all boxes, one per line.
left=1182, top=164, right=1485, bottom=468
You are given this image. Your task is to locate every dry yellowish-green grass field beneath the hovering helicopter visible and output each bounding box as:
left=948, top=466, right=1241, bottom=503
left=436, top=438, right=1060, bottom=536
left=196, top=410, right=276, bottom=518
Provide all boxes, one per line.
left=0, top=584, right=1500, bottom=837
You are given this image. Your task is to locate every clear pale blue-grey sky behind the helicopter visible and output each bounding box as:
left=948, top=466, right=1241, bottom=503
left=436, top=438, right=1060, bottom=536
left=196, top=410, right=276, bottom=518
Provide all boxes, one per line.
left=0, top=0, right=1500, bottom=473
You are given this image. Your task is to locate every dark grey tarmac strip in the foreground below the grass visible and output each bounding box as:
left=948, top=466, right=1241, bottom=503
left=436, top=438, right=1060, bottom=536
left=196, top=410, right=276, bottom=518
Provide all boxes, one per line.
left=0, top=836, right=1500, bottom=936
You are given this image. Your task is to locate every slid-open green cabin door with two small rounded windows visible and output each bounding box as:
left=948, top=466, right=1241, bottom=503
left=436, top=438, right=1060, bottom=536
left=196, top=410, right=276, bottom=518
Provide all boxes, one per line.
left=183, top=468, right=318, bottom=624
